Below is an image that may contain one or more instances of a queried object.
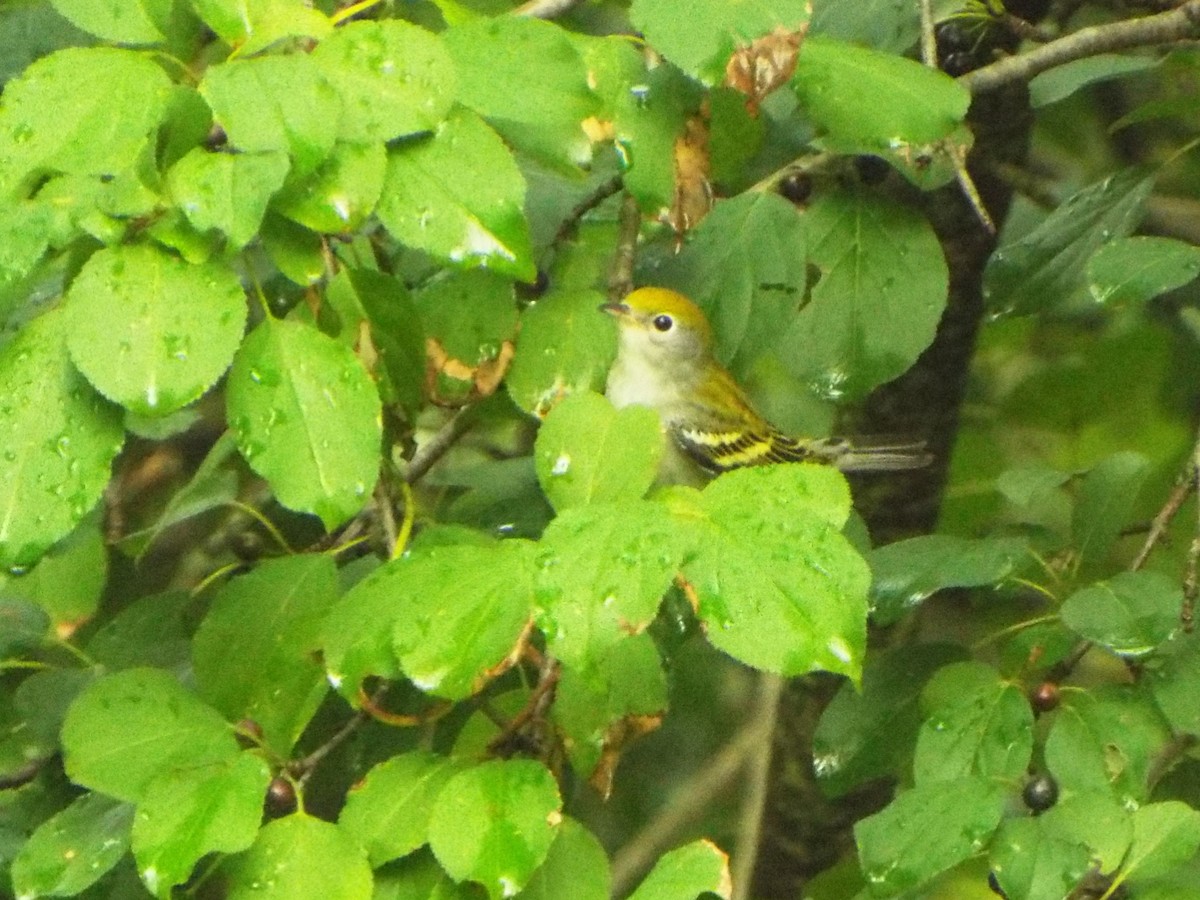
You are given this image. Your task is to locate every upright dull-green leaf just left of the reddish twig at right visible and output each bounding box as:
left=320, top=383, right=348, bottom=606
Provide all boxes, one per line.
left=1070, top=452, right=1150, bottom=568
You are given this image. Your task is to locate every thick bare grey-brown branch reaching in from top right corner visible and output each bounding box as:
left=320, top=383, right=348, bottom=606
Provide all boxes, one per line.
left=959, top=0, right=1200, bottom=95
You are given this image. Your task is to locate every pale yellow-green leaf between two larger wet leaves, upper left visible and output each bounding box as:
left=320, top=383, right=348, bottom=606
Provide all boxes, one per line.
left=199, top=53, right=341, bottom=175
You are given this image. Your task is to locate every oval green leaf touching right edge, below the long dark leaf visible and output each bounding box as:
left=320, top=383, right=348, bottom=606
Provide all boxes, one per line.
left=1087, top=236, right=1200, bottom=305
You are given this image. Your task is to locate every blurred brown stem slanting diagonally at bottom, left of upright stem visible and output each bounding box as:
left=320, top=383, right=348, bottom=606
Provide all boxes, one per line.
left=612, top=721, right=763, bottom=896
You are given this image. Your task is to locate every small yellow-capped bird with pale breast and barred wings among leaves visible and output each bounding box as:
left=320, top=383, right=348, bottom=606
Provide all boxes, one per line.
left=600, top=288, right=930, bottom=481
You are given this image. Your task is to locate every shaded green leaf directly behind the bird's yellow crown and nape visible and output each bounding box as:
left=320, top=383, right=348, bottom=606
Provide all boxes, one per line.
left=662, top=191, right=808, bottom=378
